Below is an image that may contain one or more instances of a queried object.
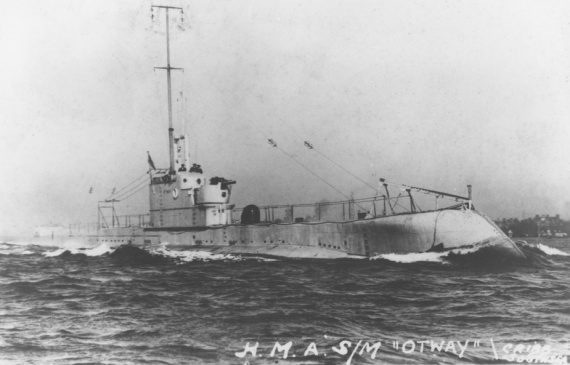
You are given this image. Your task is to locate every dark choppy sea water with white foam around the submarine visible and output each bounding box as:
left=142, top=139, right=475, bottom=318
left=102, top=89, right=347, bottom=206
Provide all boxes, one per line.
left=0, top=240, right=570, bottom=364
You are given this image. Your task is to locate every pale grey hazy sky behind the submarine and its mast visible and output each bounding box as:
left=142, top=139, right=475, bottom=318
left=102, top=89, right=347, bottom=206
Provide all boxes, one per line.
left=0, top=0, right=570, bottom=233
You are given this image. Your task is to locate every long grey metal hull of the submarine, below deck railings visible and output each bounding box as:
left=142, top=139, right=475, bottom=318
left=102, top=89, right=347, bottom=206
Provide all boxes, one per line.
left=89, top=209, right=525, bottom=259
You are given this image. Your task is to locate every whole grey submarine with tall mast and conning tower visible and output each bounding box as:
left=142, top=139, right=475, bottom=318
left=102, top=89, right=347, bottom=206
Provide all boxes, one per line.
left=74, top=6, right=525, bottom=260
